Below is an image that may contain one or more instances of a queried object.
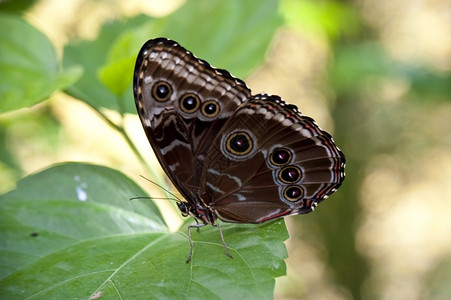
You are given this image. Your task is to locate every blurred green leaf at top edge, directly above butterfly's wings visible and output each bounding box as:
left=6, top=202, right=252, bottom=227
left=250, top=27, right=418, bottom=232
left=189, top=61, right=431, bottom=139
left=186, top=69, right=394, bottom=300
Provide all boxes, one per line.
left=162, top=0, right=282, bottom=78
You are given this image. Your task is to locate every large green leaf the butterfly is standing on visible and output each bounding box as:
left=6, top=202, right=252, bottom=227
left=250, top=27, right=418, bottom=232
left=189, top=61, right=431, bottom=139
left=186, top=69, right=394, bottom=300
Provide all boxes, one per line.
left=0, top=163, right=288, bottom=299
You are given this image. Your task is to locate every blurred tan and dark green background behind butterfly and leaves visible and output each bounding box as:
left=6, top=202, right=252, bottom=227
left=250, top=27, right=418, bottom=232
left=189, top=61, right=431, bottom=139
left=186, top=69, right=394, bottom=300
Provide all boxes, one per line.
left=0, top=0, right=451, bottom=299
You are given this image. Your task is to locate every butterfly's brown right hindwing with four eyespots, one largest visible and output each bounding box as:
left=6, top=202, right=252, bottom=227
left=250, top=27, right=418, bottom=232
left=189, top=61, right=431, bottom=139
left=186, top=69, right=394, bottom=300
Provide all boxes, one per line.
left=200, top=95, right=345, bottom=223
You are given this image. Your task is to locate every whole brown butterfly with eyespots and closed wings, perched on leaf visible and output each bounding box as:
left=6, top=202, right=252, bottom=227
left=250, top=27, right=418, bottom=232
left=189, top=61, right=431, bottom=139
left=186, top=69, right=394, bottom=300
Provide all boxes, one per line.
left=133, top=38, right=346, bottom=262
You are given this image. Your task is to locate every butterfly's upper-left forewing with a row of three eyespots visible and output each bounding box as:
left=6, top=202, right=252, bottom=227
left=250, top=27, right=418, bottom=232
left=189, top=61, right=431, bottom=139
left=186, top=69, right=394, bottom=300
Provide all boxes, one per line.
left=133, top=38, right=251, bottom=201
